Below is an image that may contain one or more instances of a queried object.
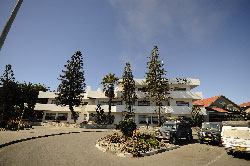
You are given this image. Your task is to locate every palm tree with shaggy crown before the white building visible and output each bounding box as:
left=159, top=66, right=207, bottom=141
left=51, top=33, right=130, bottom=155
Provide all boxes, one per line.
left=101, top=73, right=119, bottom=124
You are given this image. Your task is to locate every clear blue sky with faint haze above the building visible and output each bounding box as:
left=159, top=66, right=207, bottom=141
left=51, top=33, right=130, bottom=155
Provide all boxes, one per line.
left=0, top=0, right=250, bottom=104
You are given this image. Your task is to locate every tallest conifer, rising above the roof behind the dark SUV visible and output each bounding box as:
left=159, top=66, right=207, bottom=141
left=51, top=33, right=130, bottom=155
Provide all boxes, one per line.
left=146, top=46, right=169, bottom=126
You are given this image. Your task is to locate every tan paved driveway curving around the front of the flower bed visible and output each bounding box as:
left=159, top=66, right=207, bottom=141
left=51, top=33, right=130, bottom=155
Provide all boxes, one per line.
left=0, top=132, right=250, bottom=166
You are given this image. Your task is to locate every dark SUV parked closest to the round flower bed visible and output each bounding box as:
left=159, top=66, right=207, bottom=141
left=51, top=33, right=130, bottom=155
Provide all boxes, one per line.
left=155, top=121, right=193, bottom=144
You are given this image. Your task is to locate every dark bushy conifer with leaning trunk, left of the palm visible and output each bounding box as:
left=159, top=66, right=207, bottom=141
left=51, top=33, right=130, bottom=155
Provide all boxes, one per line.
left=57, top=51, right=86, bottom=122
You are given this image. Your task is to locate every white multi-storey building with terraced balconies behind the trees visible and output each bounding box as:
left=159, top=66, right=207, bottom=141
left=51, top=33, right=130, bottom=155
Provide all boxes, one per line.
left=35, top=78, right=202, bottom=125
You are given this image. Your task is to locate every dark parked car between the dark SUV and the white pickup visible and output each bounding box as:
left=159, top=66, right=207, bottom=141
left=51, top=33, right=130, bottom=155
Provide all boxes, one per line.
left=198, top=122, right=222, bottom=146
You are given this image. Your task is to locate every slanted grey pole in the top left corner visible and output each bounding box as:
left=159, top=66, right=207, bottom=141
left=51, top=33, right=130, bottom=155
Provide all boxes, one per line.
left=0, top=0, right=23, bottom=51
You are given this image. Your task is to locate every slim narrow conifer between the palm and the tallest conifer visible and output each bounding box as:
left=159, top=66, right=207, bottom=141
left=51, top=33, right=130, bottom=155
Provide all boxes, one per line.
left=122, top=62, right=137, bottom=118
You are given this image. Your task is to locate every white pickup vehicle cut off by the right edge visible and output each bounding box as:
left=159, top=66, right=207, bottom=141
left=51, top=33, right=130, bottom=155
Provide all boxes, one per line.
left=221, top=120, right=250, bottom=154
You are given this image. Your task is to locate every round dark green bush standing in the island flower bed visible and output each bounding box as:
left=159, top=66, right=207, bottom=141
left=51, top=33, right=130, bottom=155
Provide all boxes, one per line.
left=119, top=118, right=136, bottom=137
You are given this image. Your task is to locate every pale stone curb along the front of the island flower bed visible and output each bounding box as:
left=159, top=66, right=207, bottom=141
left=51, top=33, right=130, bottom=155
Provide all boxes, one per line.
left=95, top=144, right=180, bottom=157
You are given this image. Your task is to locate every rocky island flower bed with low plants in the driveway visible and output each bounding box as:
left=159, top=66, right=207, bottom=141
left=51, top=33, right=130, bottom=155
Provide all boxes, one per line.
left=97, top=133, right=177, bottom=157
